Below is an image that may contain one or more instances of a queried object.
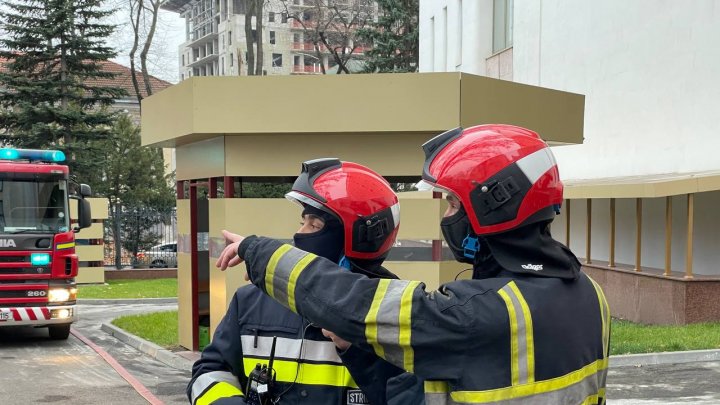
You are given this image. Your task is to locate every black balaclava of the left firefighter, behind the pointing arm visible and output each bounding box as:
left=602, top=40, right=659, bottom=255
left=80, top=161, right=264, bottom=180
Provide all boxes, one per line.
left=293, top=204, right=345, bottom=263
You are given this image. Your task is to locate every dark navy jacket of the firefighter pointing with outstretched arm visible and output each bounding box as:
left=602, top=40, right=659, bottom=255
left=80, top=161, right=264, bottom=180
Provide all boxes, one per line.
left=239, top=237, right=610, bottom=405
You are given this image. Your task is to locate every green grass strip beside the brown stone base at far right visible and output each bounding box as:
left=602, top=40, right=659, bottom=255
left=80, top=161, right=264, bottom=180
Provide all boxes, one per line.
left=610, top=319, right=720, bottom=354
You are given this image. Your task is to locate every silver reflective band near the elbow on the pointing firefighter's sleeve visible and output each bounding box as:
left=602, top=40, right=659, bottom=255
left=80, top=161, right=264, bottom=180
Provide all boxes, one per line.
left=377, top=280, right=410, bottom=365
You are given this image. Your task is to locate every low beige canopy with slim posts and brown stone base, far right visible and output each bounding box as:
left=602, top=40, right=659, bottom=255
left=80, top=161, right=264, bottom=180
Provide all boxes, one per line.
left=554, top=171, right=720, bottom=324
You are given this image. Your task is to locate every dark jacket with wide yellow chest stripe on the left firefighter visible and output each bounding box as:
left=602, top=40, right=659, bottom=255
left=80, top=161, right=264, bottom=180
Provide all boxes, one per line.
left=187, top=269, right=402, bottom=405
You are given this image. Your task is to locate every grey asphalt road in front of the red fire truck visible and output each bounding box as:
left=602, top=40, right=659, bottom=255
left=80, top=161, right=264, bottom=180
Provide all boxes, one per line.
left=0, top=304, right=190, bottom=405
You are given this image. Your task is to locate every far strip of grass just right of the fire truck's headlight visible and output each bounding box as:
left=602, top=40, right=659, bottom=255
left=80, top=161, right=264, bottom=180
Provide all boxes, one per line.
left=78, top=278, right=177, bottom=299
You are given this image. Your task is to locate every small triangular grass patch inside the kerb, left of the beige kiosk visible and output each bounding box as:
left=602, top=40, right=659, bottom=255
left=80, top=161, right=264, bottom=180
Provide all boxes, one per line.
left=112, top=311, right=178, bottom=348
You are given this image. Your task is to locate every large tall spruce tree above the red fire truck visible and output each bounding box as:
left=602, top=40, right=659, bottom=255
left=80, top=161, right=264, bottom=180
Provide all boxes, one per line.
left=0, top=0, right=125, bottom=176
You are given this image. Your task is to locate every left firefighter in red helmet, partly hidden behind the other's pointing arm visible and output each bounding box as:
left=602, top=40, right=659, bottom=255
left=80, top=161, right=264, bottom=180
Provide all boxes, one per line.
left=187, top=159, right=402, bottom=405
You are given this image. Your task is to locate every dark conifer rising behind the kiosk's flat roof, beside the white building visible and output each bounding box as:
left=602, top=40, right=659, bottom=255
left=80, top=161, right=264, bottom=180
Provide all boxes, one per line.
left=358, top=0, right=420, bottom=73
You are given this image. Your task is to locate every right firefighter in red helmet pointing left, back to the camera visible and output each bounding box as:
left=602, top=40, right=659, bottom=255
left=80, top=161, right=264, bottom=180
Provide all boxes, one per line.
left=217, top=125, right=610, bottom=404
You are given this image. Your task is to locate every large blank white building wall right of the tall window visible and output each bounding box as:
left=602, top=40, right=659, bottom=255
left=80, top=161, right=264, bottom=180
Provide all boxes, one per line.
left=513, top=0, right=720, bottom=178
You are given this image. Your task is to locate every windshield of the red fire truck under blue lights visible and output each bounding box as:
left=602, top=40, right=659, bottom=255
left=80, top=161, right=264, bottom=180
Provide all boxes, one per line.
left=0, top=179, right=70, bottom=233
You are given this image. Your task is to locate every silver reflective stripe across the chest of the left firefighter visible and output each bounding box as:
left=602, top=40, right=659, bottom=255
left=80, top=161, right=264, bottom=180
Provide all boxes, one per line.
left=240, top=335, right=342, bottom=364
